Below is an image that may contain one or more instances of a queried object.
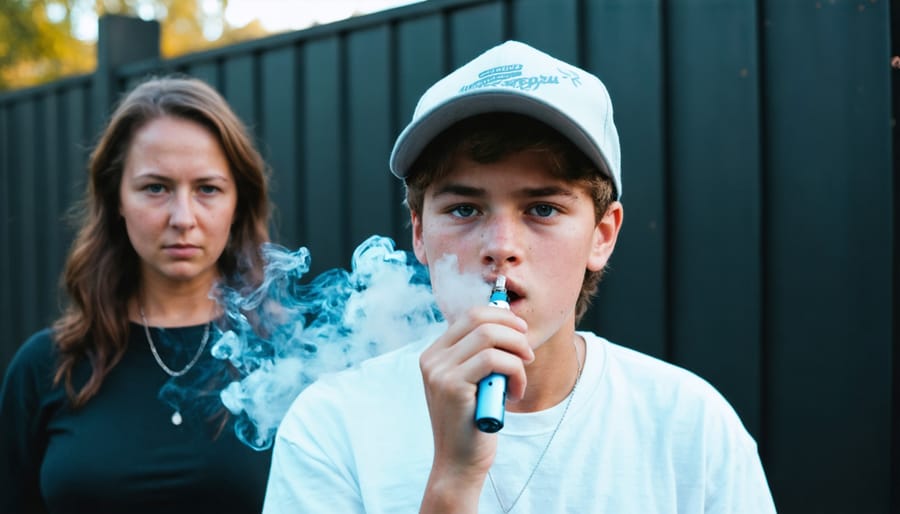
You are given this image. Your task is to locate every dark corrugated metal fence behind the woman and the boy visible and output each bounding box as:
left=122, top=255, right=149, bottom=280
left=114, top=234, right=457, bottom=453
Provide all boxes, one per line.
left=0, top=0, right=900, bottom=513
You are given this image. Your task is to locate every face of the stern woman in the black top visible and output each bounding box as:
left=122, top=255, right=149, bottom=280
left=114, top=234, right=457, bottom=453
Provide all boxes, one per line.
left=119, top=116, right=238, bottom=289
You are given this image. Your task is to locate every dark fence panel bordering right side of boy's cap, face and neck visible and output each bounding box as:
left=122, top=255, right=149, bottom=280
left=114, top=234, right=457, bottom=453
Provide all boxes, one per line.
left=583, top=0, right=668, bottom=358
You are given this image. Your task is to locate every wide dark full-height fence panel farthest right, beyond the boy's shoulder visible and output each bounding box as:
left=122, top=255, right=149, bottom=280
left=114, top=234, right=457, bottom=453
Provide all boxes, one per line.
left=763, top=0, right=897, bottom=513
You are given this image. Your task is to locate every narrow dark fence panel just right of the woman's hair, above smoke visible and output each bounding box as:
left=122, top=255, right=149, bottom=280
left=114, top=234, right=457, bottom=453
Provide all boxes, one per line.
left=260, top=46, right=304, bottom=248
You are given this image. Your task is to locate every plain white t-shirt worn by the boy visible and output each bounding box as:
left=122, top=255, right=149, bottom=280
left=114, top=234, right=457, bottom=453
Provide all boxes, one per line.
left=263, top=332, right=775, bottom=514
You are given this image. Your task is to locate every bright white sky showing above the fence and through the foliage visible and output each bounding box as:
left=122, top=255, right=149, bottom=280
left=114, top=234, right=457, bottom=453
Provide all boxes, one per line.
left=64, top=0, right=421, bottom=41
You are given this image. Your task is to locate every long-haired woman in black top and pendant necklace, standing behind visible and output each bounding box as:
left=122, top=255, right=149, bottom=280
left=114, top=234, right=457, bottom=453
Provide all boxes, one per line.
left=0, top=78, right=271, bottom=513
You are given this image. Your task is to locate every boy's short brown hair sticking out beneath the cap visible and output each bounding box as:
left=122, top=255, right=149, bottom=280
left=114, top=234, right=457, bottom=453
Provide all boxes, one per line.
left=406, top=113, right=615, bottom=322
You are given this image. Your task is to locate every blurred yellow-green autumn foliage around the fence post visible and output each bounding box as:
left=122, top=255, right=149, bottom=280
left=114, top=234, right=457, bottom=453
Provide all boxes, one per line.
left=0, top=0, right=267, bottom=90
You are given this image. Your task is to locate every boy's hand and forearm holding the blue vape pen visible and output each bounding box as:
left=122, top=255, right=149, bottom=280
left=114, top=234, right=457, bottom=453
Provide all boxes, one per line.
left=419, top=306, right=534, bottom=512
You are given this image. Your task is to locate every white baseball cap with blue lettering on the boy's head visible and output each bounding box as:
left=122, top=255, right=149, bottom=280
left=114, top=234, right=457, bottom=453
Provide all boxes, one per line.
left=390, top=41, right=622, bottom=198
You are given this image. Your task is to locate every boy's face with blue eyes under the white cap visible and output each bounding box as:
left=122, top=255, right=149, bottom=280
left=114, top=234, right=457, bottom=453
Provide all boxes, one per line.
left=412, top=152, right=622, bottom=348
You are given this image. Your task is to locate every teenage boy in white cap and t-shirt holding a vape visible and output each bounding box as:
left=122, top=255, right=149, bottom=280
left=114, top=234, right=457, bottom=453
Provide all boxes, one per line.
left=264, top=41, right=775, bottom=514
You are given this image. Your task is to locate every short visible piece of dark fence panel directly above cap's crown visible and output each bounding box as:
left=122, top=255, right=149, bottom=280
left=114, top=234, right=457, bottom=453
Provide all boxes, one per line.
left=510, top=0, right=580, bottom=64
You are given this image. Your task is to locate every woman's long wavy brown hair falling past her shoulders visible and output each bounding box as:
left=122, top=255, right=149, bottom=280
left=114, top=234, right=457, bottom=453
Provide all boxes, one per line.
left=53, top=76, right=270, bottom=407
